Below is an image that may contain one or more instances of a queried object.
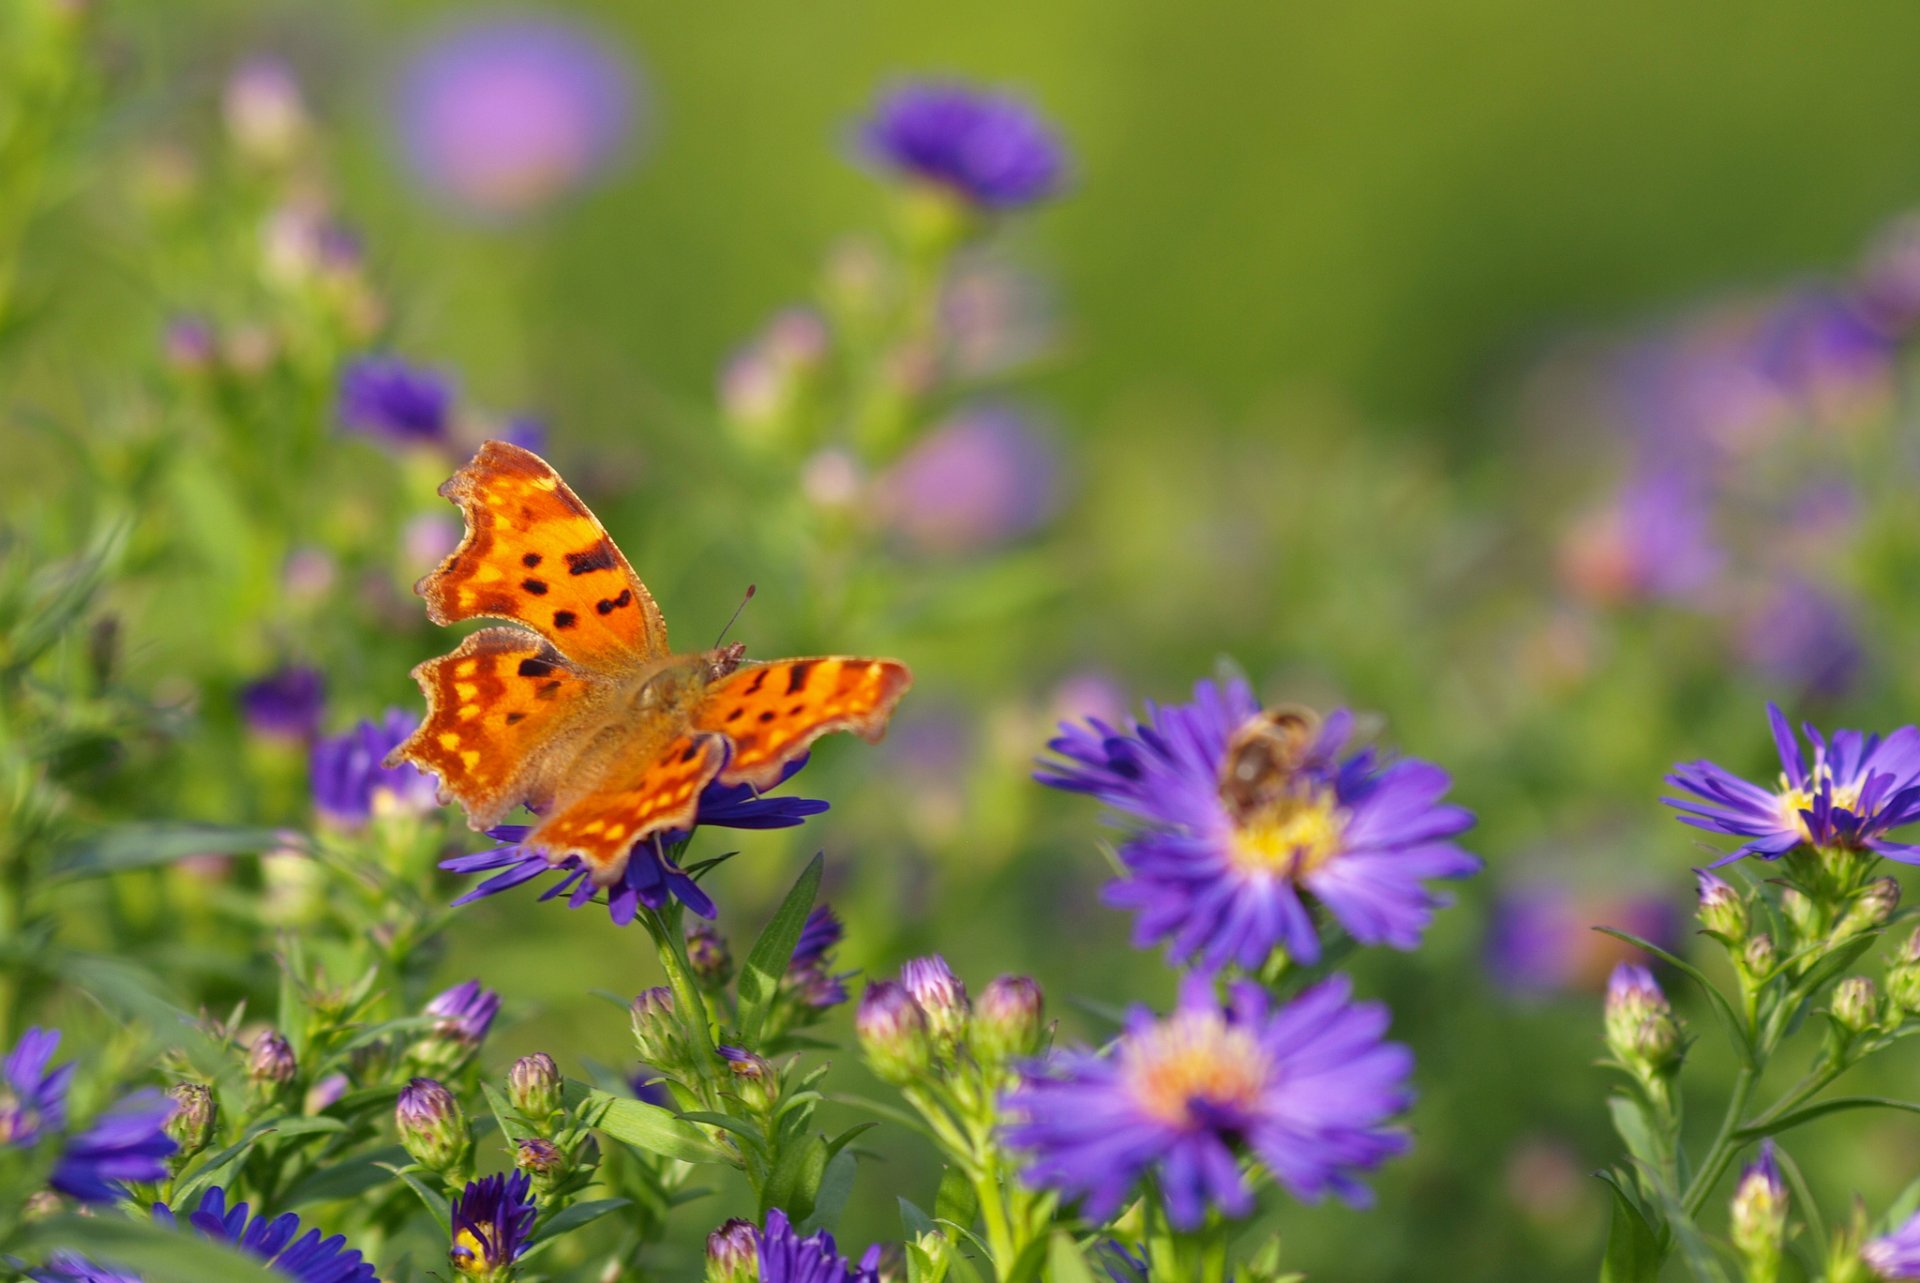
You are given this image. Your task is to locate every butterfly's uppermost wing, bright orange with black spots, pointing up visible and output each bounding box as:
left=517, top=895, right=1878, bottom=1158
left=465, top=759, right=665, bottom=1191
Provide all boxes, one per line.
left=415, top=442, right=668, bottom=672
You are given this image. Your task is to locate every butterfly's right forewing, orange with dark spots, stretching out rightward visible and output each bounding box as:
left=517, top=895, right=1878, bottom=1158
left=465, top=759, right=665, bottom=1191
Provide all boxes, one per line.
left=691, top=655, right=914, bottom=789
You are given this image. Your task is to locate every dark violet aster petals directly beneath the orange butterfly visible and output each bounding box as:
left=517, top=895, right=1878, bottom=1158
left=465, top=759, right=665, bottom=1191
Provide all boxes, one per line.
left=440, top=757, right=828, bottom=926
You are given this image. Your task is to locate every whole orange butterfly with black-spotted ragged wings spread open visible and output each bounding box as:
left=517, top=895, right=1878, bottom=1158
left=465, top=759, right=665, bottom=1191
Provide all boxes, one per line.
left=386, top=442, right=912, bottom=887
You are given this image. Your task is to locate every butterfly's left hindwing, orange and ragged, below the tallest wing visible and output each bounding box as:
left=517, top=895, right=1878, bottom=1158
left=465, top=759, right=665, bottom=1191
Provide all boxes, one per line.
left=388, top=628, right=601, bottom=828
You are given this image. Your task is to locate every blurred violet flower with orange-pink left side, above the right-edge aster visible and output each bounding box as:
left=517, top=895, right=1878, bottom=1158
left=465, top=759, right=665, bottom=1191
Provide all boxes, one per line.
left=1561, top=469, right=1724, bottom=603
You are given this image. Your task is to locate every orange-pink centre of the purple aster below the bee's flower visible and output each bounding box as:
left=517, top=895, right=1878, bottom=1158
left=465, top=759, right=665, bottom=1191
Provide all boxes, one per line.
left=1119, top=1012, right=1271, bottom=1127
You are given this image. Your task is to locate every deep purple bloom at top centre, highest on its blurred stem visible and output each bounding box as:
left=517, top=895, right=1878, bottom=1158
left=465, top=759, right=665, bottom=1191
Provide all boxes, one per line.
left=860, top=81, right=1066, bottom=209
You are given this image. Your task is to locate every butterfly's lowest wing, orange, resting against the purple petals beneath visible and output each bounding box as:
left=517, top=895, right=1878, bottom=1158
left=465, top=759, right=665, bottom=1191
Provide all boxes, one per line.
left=526, top=734, right=726, bottom=885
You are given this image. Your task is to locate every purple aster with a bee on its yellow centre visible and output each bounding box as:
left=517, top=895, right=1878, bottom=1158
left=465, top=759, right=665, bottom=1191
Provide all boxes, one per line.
left=1035, top=680, right=1480, bottom=968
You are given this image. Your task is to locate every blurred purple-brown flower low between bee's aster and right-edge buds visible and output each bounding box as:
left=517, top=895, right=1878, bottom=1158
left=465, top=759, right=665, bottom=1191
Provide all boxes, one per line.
left=1484, top=882, right=1680, bottom=997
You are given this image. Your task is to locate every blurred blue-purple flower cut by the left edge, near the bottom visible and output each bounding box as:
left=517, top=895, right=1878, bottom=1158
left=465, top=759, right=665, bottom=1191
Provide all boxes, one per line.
left=0, top=1029, right=179, bottom=1202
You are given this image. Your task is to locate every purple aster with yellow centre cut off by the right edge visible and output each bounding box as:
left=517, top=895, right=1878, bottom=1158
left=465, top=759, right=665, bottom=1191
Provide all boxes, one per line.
left=1665, top=705, right=1920, bottom=868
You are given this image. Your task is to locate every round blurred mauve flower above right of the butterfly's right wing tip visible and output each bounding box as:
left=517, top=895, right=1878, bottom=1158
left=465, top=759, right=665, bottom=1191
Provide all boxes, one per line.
left=874, top=405, right=1060, bottom=555
